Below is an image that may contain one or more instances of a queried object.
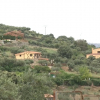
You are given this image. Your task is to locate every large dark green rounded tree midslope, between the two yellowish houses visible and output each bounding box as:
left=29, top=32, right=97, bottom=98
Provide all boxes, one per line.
left=58, top=45, right=72, bottom=58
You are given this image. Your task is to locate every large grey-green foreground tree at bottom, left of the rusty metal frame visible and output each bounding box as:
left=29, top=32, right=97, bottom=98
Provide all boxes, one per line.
left=19, top=71, right=54, bottom=100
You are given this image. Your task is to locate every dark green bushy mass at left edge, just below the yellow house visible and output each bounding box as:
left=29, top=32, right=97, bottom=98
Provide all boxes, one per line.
left=0, top=58, right=31, bottom=72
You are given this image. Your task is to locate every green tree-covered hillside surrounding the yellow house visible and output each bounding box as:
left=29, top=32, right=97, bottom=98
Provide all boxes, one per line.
left=0, top=24, right=100, bottom=100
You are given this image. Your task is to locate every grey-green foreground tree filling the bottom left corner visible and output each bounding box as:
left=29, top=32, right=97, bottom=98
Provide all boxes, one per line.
left=0, top=72, right=20, bottom=100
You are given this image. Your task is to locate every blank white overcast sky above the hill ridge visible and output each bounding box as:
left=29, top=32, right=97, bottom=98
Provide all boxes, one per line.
left=0, top=0, right=100, bottom=43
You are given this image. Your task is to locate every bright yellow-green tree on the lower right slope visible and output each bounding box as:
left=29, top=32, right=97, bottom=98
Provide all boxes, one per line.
left=79, top=66, right=91, bottom=80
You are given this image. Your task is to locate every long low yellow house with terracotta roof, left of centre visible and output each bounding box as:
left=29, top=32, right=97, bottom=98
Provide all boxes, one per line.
left=15, top=51, right=41, bottom=59
